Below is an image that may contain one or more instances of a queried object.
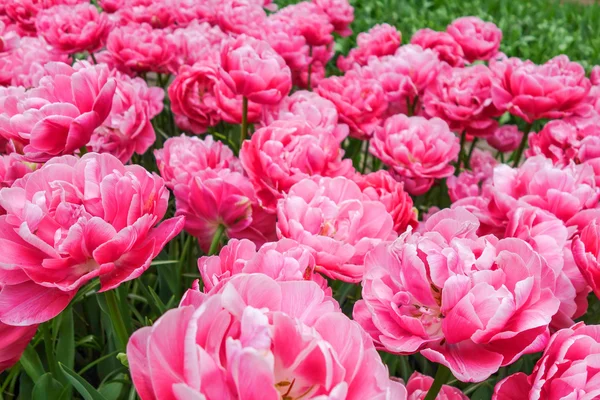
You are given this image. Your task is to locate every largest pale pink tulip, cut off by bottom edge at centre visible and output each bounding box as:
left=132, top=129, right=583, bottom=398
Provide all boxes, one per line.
left=127, top=274, right=406, bottom=400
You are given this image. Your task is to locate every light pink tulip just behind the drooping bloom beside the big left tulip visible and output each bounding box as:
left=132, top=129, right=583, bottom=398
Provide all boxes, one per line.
left=154, top=135, right=243, bottom=189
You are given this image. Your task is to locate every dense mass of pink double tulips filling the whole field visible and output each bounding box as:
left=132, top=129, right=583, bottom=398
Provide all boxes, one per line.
left=0, top=0, right=600, bottom=400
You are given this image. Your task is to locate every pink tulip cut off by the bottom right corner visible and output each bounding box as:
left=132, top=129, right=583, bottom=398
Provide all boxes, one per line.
left=492, top=323, right=600, bottom=400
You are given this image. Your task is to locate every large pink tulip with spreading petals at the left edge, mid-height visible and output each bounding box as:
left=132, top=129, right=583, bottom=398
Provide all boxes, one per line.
left=0, top=153, right=184, bottom=326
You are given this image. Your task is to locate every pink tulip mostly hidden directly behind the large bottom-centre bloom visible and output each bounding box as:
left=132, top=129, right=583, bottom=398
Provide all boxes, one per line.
left=198, top=239, right=331, bottom=294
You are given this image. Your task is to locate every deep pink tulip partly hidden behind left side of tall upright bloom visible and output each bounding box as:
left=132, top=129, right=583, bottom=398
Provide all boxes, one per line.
left=169, top=63, right=221, bottom=134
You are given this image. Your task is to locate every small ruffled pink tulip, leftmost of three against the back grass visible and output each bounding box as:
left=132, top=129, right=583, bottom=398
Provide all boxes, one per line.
left=337, top=24, right=402, bottom=71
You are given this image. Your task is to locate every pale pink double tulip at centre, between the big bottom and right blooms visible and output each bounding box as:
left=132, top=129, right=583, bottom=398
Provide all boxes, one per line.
left=277, top=177, right=397, bottom=282
